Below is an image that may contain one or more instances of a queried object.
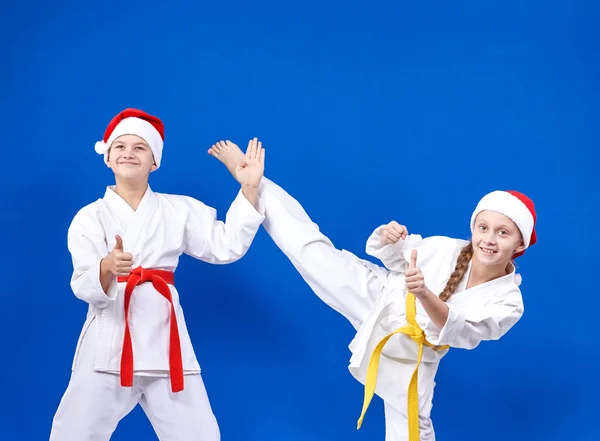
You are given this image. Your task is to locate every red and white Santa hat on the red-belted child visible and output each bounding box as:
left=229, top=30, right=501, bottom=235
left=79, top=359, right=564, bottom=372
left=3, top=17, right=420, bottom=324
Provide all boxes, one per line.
left=95, top=109, right=165, bottom=168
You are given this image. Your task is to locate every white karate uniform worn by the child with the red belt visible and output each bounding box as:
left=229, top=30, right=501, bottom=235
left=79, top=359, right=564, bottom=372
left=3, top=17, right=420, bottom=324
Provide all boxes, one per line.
left=50, top=187, right=264, bottom=441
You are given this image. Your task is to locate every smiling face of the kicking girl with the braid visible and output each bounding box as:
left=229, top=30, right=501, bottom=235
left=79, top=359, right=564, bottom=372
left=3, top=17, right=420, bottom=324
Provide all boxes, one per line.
left=472, top=210, right=525, bottom=267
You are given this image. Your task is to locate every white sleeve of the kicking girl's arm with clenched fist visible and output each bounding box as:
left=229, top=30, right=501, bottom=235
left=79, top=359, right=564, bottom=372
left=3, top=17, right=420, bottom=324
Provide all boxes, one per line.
left=366, top=225, right=422, bottom=273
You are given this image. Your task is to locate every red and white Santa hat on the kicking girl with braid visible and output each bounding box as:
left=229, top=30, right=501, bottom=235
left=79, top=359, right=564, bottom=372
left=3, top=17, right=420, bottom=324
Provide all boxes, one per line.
left=471, top=190, right=537, bottom=258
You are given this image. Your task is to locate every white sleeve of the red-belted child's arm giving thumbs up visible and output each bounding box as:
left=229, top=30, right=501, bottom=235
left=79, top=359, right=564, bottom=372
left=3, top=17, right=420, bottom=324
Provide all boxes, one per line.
left=67, top=211, right=117, bottom=309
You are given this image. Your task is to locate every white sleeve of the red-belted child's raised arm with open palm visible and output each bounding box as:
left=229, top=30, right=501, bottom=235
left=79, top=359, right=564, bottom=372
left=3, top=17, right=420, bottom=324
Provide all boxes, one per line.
left=184, top=190, right=265, bottom=264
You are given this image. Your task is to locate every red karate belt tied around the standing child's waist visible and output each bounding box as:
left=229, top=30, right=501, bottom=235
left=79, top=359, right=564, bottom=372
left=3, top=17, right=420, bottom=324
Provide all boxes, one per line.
left=117, top=267, right=183, bottom=392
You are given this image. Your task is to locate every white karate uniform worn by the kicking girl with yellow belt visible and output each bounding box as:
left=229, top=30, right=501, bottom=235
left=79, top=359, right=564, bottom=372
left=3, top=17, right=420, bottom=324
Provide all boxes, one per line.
left=259, top=178, right=523, bottom=441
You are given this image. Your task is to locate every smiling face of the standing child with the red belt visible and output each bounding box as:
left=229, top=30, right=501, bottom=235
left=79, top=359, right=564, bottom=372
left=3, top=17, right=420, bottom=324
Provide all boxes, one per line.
left=108, top=135, right=157, bottom=180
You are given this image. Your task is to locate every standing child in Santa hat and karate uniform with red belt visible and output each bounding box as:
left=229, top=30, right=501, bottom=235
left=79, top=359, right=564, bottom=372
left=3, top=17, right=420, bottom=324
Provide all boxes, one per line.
left=50, top=109, right=264, bottom=441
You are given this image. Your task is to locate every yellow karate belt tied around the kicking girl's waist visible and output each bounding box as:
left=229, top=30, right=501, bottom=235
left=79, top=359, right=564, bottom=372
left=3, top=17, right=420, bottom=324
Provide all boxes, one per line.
left=358, top=292, right=449, bottom=441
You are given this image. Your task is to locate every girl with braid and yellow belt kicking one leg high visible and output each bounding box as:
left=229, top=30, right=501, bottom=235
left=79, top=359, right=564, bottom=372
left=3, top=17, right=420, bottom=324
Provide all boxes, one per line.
left=209, top=142, right=536, bottom=441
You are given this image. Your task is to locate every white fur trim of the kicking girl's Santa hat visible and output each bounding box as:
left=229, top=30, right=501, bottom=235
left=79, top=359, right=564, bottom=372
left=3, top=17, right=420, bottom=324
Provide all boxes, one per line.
left=471, top=191, right=534, bottom=248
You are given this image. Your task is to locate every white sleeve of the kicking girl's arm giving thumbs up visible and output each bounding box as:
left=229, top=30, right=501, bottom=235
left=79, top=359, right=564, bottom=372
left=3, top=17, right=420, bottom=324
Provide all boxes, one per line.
left=426, top=292, right=524, bottom=349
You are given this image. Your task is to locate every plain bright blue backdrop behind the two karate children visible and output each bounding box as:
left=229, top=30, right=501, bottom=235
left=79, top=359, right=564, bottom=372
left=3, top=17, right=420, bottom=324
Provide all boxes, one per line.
left=0, top=0, right=600, bottom=441
